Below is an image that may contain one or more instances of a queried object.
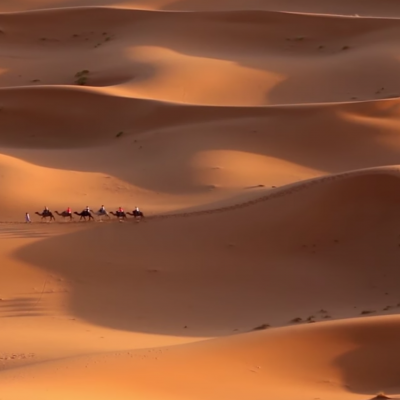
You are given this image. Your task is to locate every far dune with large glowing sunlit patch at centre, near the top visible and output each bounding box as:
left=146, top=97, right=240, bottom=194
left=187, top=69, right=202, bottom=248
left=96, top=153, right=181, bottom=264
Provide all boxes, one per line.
left=0, top=8, right=400, bottom=106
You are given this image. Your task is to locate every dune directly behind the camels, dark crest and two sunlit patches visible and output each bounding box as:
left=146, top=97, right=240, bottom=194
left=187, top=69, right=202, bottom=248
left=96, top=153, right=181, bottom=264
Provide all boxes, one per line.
left=0, top=92, right=399, bottom=220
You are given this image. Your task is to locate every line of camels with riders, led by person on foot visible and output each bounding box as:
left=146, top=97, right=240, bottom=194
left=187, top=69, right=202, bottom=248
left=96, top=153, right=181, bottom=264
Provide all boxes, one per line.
left=33, top=205, right=144, bottom=222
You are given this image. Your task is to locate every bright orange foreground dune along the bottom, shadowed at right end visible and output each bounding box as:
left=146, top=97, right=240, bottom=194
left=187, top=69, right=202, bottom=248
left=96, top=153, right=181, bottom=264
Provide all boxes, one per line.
left=0, top=317, right=399, bottom=399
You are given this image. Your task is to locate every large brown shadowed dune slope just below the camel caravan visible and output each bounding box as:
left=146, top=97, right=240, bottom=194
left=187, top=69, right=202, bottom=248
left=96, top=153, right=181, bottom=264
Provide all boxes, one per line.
left=14, top=173, right=400, bottom=337
